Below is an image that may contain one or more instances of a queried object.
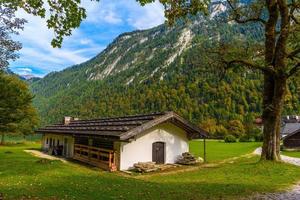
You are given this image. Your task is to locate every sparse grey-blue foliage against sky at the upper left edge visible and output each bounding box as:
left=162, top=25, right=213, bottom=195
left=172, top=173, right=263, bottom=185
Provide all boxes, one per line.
left=0, top=3, right=26, bottom=70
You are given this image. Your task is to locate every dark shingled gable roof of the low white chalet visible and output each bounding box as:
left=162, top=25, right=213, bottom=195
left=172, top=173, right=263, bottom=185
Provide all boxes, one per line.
left=36, top=112, right=207, bottom=140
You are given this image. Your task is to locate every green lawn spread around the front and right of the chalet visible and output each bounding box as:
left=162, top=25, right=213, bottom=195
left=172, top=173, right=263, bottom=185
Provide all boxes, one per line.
left=0, top=141, right=300, bottom=200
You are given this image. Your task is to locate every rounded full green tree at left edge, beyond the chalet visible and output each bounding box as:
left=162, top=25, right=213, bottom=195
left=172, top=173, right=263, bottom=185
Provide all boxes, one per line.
left=0, top=72, right=38, bottom=144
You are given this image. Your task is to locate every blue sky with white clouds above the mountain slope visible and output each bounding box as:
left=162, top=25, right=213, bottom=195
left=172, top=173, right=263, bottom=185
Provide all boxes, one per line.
left=10, top=0, right=164, bottom=77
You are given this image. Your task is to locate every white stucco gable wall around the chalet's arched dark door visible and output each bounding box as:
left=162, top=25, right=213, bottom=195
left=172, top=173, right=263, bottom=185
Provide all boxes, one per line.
left=120, top=123, right=189, bottom=170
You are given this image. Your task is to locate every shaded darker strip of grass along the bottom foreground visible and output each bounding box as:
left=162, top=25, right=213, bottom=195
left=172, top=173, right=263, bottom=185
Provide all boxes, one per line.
left=1, top=174, right=278, bottom=199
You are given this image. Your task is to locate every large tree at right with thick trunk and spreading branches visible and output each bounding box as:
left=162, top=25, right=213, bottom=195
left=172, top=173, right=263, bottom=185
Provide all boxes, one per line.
left=141, top=0, right=300, bottom=161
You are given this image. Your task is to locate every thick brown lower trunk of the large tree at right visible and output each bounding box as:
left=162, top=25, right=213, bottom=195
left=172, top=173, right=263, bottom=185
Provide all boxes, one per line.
left=261, top=74, right=286, bottom=161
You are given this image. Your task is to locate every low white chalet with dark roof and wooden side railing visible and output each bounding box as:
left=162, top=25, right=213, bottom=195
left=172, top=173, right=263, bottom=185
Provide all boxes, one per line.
left=37, top=112, right=207, bottom=171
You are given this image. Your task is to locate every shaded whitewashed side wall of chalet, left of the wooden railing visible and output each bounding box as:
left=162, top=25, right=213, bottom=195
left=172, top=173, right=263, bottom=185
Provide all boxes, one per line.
left=42, top=133, right=74, bottom=157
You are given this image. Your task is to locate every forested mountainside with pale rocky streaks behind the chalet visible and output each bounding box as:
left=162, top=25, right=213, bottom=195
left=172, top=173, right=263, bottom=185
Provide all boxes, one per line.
left=31, top=4, right=300, bottom=138
